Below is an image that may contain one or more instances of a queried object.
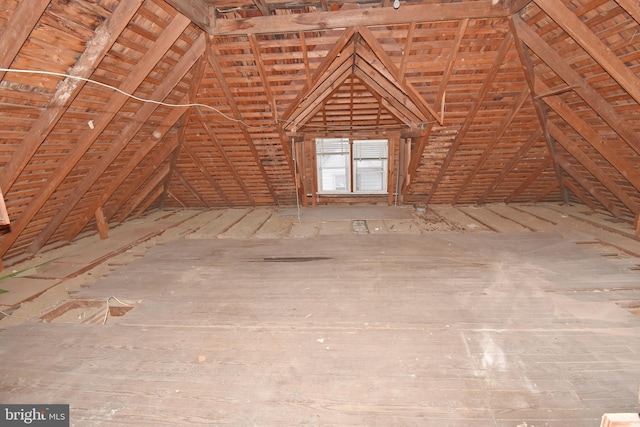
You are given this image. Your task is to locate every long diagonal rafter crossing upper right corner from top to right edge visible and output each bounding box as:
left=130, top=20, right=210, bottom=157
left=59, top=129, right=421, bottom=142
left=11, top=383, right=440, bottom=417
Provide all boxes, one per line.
left=534, top=0, right=640, bottom=104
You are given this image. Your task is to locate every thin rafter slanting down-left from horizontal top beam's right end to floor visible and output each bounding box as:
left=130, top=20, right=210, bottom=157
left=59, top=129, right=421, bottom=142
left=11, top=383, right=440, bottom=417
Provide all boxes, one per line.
left=426, top=32, right=513, bottom=203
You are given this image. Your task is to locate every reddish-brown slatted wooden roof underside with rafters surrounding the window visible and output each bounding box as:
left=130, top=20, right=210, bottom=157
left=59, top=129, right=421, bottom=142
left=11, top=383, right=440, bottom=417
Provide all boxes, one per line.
left=0, top=0, right=640, bottom=268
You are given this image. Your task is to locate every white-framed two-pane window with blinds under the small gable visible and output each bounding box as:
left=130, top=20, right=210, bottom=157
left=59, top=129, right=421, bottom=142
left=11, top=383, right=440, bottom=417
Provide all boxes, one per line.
left=316, top=138, right=388, bottom=194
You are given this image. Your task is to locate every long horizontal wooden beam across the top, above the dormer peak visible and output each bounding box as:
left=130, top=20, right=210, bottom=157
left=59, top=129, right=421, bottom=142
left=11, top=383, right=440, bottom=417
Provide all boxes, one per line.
left=208, top=1, right=511, bottom=35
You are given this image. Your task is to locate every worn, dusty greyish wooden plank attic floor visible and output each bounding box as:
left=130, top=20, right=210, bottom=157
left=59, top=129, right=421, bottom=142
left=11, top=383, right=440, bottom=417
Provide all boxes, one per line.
left=0, top=206, right=640, bottom=427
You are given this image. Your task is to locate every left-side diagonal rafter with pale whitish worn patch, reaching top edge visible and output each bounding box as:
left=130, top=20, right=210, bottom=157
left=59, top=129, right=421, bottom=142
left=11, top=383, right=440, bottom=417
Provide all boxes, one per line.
left=0, top=0, right=142, bottom=192
